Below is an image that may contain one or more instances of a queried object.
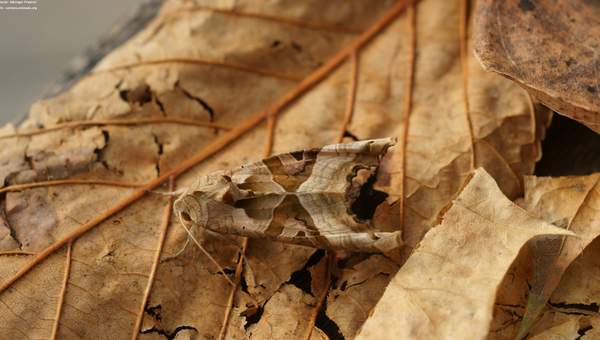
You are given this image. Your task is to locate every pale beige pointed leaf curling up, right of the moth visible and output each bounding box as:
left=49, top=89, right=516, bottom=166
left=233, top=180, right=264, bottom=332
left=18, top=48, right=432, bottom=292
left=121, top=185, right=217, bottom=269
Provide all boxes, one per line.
left=356, top=170, right=572, bottom=339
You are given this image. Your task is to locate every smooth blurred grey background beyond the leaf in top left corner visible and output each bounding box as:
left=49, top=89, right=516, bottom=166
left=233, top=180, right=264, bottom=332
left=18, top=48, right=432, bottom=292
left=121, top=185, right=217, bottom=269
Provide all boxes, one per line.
left=0, top=0, right=144, bottom=125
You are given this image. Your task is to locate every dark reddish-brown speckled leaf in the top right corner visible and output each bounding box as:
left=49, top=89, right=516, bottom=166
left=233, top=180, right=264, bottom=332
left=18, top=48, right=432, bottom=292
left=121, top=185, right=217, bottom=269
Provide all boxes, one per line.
left=475, top=0, right=600, bottom=133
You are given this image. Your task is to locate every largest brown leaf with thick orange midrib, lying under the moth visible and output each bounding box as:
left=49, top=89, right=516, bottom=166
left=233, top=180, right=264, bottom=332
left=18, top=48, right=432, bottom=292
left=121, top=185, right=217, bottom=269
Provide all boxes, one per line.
left=0, top=0, right=549, bottom=339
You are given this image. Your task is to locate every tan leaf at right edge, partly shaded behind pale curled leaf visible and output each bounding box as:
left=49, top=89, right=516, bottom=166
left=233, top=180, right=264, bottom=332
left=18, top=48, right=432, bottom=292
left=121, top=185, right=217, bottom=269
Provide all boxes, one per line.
left=517, top=175, right=600, bottom=338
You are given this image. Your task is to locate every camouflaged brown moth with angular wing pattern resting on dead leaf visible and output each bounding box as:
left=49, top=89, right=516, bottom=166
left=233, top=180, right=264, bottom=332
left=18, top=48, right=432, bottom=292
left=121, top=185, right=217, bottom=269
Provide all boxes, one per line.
left=174, top=138, right=402, bottom=252
